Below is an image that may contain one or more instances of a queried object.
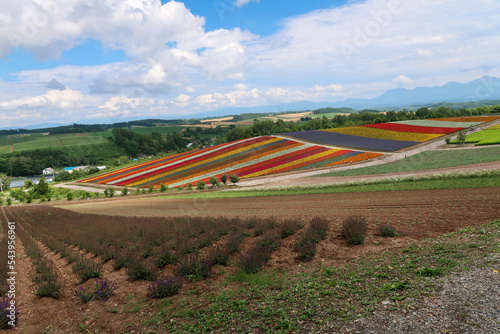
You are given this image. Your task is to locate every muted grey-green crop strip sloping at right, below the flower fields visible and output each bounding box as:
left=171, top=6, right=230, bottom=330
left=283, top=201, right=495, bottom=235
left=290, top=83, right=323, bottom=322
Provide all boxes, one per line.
left=317, top=147, right=500, bottom=177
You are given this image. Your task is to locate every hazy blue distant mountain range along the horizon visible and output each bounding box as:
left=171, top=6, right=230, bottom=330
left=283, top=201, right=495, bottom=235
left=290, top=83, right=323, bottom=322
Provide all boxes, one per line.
left=3, top=76, right=500, bottom=129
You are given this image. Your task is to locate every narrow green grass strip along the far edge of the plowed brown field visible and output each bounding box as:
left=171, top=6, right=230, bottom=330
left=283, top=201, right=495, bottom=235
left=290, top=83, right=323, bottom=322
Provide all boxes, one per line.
left=152, top=171, right=500, bottom=199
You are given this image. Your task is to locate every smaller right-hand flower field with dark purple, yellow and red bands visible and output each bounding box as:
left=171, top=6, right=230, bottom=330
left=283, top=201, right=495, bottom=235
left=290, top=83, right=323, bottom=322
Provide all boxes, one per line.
left=283, top=116, right=500, bottom=151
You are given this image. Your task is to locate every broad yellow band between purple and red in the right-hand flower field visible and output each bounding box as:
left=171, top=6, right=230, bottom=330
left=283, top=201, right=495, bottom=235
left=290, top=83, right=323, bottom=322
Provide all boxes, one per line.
left=321, top=126, right=443, bottom=142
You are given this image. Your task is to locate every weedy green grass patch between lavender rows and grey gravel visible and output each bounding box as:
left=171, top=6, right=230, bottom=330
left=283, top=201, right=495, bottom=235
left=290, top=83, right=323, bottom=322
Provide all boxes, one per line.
left=145, top=221, right=500, bottom=333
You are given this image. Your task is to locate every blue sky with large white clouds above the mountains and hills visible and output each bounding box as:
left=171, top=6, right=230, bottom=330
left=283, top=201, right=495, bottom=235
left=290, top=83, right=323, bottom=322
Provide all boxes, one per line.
left=0, top=0, right=500, bottom=128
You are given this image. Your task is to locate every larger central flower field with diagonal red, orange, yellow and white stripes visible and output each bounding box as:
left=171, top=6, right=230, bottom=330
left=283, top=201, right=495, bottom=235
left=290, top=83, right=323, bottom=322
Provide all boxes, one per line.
left=81, top=136, right=381, bottom=187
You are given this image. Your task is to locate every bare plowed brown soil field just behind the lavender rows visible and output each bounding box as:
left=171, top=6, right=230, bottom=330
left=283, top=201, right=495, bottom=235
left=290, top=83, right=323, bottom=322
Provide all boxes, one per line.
left=61, top=187, right=500, bottom=239
